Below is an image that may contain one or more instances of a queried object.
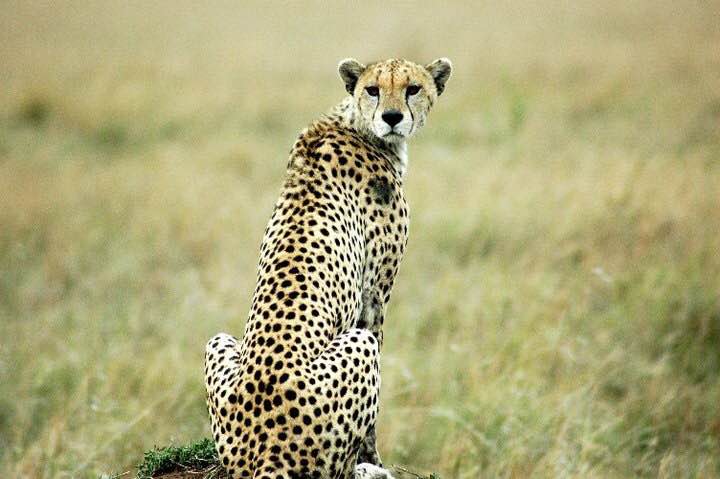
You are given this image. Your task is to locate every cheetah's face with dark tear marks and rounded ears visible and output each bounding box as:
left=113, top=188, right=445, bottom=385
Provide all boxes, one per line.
left=338, top=58, right=452, bottom=143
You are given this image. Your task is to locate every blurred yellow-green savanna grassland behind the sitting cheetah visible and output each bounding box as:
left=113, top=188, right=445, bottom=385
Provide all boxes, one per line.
left=0, top=0, right=720, bottom=479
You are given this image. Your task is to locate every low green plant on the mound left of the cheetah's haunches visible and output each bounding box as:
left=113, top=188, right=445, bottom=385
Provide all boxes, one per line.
left=137, top=438, right=220, bottom=479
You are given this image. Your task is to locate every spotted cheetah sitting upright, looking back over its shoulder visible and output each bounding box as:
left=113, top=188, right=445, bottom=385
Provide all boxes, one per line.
left=205, top=58, right=452, bottom=479
